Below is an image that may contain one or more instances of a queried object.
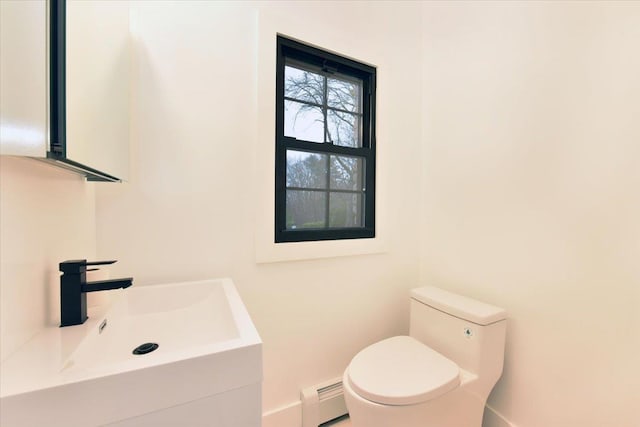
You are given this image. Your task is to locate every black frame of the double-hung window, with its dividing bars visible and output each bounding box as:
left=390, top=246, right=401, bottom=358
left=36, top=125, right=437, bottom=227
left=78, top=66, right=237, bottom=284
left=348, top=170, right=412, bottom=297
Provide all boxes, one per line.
left=275, top=35, right=376, bottom=243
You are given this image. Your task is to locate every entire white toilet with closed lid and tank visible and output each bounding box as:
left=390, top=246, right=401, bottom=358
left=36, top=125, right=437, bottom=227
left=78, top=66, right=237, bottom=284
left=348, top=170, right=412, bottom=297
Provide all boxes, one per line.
left=343, top=286, right=507, bottom=427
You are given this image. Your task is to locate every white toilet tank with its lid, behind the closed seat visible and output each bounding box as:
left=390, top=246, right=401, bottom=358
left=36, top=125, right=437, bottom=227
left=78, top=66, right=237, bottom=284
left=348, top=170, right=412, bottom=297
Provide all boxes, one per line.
left=409, top=286, right=507, bottom=389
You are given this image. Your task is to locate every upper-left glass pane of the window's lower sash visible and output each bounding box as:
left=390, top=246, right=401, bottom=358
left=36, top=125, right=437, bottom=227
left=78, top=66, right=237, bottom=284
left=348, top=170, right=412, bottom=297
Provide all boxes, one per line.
left=287, top=150, right=328, bottom=188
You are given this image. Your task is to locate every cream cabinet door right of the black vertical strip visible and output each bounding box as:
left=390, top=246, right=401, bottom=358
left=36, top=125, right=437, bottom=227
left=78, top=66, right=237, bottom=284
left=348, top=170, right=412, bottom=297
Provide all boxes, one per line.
left=66, top=0, right=131, bottom=180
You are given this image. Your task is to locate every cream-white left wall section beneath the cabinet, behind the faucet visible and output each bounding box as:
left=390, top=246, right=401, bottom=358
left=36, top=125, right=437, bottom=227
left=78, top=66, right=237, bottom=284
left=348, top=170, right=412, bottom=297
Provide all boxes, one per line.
left=0, top=156, right=96, bottom=360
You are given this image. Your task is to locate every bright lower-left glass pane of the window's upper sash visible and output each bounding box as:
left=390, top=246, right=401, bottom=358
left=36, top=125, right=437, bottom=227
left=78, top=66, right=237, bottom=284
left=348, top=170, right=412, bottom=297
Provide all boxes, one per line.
left=284, top=101, right=324, bottom=142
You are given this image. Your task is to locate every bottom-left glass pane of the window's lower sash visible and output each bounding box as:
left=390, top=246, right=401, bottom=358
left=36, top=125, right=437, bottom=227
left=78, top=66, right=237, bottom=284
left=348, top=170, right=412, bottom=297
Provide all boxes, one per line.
left=287, top=190, right=327, bottom=230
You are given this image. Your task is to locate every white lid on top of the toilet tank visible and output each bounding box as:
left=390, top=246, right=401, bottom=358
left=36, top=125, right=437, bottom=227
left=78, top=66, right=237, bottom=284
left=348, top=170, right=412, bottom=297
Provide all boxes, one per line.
left=411, top=286, right=507, bottom=326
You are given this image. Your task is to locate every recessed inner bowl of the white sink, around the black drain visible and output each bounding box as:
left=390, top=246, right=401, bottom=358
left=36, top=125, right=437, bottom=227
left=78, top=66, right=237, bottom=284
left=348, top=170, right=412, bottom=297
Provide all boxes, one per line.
left=62, top=281, right=240, bottom=375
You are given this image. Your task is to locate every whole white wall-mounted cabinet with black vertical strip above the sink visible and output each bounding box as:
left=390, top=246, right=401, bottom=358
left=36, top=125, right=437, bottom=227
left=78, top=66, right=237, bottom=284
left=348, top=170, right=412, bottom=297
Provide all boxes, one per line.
left=0, top=0, right=131, bottom=181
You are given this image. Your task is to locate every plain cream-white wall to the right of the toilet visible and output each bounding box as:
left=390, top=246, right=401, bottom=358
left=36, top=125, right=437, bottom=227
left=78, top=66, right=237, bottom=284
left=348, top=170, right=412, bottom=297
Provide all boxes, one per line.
left=421, top=2, right=640, bottom=427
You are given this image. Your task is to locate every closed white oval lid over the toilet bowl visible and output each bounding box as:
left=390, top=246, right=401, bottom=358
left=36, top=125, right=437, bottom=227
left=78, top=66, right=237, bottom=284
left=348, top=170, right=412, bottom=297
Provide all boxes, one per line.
left=348, top=336, right=460, bottom=405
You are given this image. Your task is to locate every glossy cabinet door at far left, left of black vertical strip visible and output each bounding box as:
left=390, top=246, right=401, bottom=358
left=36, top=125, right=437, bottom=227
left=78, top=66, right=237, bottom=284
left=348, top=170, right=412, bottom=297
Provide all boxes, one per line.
left=0, top=0, right=49, bottom=157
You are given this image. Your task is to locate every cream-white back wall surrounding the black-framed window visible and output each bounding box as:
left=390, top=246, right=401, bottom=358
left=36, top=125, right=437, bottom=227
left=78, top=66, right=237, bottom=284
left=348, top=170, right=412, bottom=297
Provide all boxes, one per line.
left=97, top=1, right=421, bottom=418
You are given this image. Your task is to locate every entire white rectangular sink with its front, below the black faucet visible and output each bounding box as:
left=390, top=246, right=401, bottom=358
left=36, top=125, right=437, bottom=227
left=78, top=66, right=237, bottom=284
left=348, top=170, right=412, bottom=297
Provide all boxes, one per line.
left=0, top=279, right=262, bottom=427
